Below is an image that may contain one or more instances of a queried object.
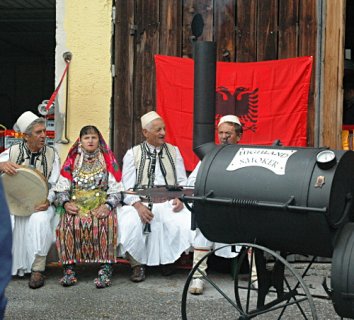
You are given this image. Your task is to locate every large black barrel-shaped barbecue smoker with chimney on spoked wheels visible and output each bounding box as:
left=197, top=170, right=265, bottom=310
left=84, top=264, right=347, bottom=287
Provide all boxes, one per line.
left=182, top=42, right=354, bottom=319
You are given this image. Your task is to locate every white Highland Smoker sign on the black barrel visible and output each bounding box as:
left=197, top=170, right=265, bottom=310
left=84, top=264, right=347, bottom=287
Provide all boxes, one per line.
left=226, top=148, right=296, bottom=175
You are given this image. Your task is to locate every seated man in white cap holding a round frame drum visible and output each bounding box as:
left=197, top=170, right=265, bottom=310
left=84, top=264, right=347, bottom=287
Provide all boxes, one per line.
left=0, top=111, right=60, bottom=289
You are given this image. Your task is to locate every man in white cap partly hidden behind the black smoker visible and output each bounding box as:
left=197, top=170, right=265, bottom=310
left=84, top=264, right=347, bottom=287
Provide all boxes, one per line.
left=187, top=115, right=243, bottom=294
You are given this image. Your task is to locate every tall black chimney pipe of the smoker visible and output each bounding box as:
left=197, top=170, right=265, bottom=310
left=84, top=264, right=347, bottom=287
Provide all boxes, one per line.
left=193, top=41, right=216, bottom=159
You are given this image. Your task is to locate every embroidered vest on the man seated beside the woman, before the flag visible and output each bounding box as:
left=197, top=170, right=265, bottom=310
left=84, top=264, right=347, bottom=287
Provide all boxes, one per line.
left=133, top=142, right=177, bottom=187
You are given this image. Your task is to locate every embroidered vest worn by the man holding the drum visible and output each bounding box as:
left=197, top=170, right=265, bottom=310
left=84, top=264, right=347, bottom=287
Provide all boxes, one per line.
left=9, top=143, right=55, bottom=179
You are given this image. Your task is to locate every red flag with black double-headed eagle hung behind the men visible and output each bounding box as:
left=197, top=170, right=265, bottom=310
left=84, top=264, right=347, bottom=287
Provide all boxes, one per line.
left=155, top=55, right=313, bottom=171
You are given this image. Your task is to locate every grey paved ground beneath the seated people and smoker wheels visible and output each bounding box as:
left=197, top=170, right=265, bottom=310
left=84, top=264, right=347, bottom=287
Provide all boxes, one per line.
left=5, top=263, right=340, bottom=320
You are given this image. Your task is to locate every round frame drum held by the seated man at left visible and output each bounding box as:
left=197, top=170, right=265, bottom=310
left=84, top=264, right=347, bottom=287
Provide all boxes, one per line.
left=1, top=166, right=48, bottom=217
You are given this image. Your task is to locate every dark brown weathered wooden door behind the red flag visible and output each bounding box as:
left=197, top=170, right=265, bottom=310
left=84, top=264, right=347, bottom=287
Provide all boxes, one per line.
left=113, top=0, right=317, bottom=161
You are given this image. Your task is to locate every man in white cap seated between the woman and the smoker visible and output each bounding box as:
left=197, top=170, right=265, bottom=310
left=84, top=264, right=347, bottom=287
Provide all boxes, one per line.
left=118, top=111, right=192, bottom=282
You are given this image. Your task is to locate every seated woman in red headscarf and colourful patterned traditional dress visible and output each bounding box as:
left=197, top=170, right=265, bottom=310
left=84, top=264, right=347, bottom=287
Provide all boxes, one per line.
left=55, top=126, right=123, bottom=288
